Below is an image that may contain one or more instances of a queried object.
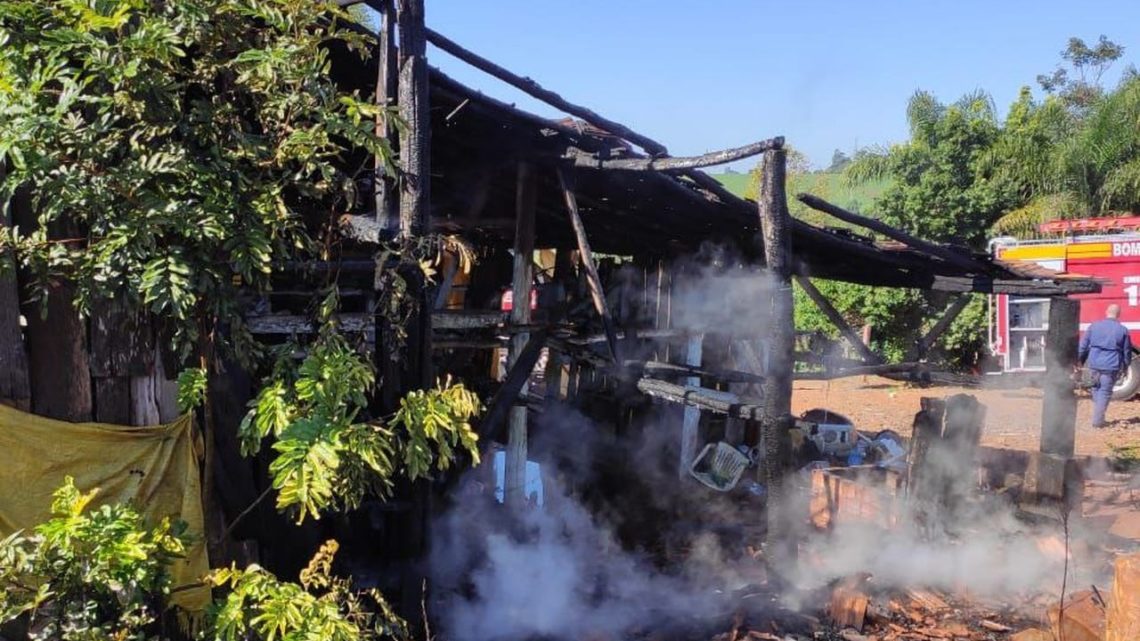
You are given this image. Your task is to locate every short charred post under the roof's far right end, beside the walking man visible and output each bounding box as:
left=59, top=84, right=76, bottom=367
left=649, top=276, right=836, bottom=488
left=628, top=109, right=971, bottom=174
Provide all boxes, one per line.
left=1041, top=298, right=1081, bottom=456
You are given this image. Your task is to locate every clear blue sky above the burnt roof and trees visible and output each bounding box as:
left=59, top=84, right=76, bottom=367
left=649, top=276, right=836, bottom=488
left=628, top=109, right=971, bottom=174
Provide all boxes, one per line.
left=414, top=0, right=1140, bottom=165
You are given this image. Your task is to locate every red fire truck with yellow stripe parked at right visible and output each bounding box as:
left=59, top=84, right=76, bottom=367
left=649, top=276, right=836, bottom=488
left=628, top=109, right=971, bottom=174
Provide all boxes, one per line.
left=990, top=216, right=1140, bottom=399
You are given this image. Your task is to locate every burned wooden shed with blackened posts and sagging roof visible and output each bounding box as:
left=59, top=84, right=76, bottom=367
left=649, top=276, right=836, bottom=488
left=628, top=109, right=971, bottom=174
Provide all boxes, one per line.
left=0, top=0, right=1097, bottom=615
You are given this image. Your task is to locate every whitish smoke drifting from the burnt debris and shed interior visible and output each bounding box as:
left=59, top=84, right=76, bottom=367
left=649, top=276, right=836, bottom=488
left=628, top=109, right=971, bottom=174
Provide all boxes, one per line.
left=431, top=255, right=1103, bottom=641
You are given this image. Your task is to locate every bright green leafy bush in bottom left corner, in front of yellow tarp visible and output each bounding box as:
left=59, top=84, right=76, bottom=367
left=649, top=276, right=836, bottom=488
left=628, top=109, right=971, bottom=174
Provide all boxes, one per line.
left=0, top=477, right=188, bottom=641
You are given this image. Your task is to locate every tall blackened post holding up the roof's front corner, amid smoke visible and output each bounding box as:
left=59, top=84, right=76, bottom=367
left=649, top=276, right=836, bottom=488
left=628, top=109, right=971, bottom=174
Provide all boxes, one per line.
left=758, top=144, right=796, bottom=561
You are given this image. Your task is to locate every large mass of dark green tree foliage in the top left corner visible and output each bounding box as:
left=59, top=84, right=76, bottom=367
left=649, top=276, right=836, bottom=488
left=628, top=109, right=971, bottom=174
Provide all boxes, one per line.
left=0, top=0, right=391, bottom=362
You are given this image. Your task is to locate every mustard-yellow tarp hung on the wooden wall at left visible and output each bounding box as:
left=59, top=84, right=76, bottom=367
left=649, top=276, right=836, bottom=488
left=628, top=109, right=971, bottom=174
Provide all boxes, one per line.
left=0, top=405, right=210, bottom=612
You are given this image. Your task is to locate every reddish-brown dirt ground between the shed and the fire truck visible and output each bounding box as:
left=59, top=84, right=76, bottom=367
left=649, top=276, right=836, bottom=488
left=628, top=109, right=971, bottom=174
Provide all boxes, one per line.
left=792, top=376, right=1140, bottom=456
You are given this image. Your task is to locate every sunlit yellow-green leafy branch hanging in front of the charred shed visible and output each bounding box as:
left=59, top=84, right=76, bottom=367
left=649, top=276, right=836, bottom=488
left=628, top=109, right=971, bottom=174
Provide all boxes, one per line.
left=238, top=292, right=481, bottom=521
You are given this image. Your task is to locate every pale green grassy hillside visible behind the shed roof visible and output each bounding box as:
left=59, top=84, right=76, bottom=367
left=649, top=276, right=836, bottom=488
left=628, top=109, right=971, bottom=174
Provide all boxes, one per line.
left=710, top=171, right=890, bottom=226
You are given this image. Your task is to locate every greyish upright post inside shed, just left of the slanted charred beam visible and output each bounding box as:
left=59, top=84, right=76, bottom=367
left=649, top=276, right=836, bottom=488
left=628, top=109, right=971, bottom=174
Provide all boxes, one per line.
left=504, top=163, right=538, bottom=508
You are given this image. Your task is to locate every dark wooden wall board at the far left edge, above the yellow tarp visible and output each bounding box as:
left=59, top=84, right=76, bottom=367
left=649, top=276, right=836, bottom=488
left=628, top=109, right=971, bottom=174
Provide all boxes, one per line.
left=0, top=161, right=32, bottom=412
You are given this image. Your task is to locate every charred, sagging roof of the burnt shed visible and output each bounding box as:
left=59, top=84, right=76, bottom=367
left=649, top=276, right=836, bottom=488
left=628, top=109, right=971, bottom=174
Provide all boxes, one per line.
left=330, top=16, right=1099, bottom=295
